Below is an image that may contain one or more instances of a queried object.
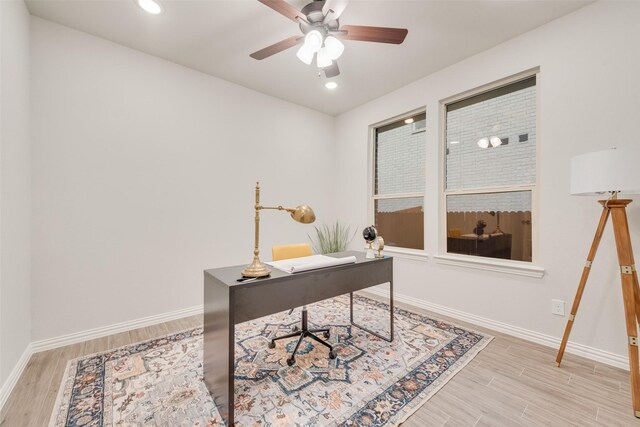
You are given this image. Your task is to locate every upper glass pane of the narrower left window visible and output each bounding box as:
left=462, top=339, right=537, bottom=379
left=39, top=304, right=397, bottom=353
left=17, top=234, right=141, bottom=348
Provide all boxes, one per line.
left=374, top=113, right=426, bottom=195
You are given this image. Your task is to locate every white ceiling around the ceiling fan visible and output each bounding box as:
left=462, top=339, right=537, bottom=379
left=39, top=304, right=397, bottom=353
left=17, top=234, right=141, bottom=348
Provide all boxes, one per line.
left=26, top=0, right=589, bottom=115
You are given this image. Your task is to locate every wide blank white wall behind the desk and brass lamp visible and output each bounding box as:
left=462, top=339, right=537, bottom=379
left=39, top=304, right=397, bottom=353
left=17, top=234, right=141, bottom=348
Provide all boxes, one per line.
left=31, top=17, right=335, bottom=340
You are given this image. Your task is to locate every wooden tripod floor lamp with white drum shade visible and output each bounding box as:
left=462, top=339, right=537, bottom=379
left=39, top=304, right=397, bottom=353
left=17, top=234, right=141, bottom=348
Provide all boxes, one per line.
left=556, top=149, right=640, bottom=418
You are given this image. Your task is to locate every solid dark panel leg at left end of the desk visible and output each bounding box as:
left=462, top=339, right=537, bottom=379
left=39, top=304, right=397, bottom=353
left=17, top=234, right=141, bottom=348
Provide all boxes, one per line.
left=203, top=276, right=235, bottom=427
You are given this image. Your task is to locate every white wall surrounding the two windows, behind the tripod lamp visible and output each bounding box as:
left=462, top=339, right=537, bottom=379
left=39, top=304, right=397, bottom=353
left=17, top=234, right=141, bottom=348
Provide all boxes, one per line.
left=336, top=2, right=640, bottom=362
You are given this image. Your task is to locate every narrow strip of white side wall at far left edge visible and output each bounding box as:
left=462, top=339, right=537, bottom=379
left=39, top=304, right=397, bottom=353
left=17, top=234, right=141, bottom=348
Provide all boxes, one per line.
left=0, top=0, right=31, bottom=389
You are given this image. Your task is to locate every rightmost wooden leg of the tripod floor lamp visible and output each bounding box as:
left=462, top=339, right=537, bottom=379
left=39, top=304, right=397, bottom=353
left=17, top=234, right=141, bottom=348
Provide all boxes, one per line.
left=608, top=199, right=640, bottom=418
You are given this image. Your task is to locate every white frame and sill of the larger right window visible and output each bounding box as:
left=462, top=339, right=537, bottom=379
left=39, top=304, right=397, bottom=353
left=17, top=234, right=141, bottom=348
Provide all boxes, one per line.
left=435, top=67, right=544, bottom=272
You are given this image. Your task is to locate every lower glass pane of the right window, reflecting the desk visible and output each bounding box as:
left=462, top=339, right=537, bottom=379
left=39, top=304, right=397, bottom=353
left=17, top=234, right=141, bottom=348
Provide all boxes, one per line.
left=447, top=191, right=531, bottom=262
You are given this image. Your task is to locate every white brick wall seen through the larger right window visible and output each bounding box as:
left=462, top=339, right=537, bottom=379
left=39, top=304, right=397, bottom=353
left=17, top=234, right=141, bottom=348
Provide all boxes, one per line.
left=445, top=86, right=537, bottom=212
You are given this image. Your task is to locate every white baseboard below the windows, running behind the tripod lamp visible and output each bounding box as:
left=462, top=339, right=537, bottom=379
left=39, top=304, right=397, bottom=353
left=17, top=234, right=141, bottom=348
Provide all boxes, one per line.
left=365, top=288, right=629, bottom=371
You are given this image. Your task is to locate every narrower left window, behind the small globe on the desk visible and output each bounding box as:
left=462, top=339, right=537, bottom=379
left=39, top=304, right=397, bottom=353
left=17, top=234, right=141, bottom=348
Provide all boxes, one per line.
left=373, top=112, right=426, bottom=249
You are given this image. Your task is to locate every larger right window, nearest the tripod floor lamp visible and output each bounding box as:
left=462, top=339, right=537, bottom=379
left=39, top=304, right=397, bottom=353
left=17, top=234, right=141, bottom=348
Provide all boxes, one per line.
left=445, top=76, right=537, bottom=262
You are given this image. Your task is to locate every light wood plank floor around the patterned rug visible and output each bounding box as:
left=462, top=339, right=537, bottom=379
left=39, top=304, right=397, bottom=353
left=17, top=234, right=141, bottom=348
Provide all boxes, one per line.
left=0, top=304, right=640, bottom=427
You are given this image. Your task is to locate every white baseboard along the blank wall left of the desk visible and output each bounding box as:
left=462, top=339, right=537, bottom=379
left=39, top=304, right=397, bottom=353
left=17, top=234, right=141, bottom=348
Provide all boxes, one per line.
left=31, top=305, right=203, bottom=353
